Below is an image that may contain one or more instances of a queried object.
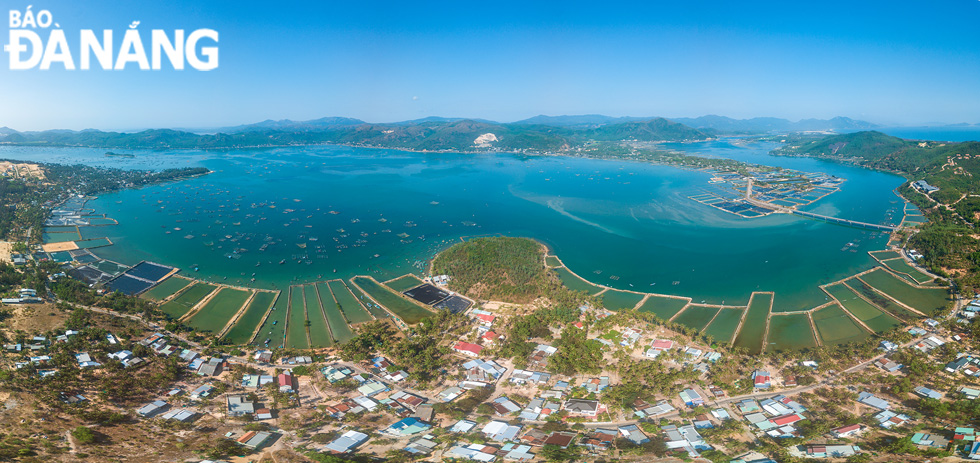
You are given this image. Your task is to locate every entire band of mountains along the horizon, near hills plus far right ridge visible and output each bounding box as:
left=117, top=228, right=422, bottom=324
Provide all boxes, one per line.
left=0, top=114, right=948, bottom=151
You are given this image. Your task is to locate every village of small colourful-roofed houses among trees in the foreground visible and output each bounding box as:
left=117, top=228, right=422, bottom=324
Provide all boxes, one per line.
left=3, top=272, right=980, bottom=462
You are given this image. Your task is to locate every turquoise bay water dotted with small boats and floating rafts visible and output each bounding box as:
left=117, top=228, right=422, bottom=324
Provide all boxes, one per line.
left=0, top=141, right=902, bottom=310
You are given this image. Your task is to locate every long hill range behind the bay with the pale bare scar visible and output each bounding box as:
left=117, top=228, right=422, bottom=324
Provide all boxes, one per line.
left=0, top=117, right=710, bottom=151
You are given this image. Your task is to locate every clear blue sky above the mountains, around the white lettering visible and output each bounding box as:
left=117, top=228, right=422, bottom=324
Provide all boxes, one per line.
left=0, top=0, right=980, bottom=130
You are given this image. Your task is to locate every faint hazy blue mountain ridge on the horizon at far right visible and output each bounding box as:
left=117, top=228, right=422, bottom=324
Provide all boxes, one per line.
left=671, top=115, right=878, bottom=133
